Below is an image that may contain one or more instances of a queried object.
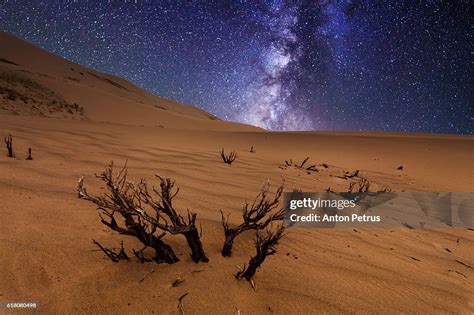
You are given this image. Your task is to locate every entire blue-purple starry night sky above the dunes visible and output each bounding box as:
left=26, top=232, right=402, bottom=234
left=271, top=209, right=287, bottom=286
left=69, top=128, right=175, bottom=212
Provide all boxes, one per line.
left=0, top=0, right=474, bottom=134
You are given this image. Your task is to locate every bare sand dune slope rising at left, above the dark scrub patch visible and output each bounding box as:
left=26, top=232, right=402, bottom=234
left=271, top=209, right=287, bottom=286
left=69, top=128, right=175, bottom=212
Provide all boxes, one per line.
left=0, top=32, right=259, bottom=130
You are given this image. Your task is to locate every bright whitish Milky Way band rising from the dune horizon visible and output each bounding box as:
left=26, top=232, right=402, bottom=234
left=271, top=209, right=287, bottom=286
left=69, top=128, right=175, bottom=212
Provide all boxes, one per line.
left=239, top=3, right=313, bottom=130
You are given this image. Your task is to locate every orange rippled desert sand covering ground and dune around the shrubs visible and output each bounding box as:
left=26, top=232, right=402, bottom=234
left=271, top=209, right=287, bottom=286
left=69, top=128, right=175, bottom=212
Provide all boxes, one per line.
left=0, top=33, right=474, bottom=314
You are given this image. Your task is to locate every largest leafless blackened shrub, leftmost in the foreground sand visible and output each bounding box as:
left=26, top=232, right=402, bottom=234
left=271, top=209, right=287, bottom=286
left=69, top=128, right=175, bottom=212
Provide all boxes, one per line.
left=77, top=162, right=208, bottom=264
